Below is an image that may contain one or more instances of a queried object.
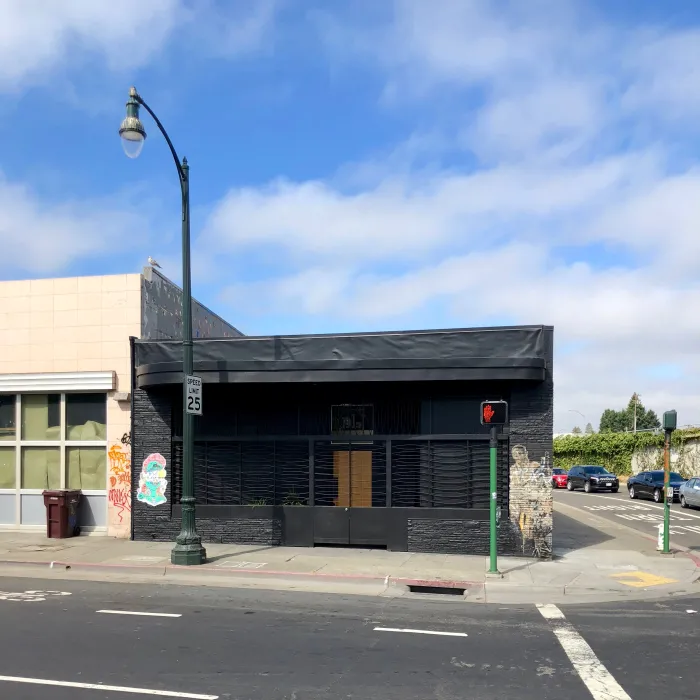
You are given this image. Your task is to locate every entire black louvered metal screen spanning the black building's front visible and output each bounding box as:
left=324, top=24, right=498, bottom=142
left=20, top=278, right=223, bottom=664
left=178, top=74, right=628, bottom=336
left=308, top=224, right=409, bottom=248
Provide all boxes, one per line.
left=171, top=439, right=509, bottom=508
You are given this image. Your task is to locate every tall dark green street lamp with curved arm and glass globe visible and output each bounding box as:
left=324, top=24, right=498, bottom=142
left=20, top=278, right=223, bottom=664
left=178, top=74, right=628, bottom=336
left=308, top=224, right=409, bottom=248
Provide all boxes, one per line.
left=119, top=87, right=207, bottom=566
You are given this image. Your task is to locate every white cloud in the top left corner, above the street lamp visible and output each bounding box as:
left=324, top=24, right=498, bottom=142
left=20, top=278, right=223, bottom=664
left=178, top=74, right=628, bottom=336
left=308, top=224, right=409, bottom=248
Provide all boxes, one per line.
left=0, top=0, right=277, bottom=92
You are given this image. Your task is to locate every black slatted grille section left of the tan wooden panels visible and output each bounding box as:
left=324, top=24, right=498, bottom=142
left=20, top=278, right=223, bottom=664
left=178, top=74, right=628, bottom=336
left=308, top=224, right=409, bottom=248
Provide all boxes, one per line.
left=172, top=440, right=309, bottom=505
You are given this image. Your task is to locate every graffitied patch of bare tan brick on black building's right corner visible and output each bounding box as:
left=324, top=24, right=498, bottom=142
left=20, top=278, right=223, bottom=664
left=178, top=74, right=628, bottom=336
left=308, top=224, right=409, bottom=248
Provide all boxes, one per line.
left=510, top=445, right=552, bottom=557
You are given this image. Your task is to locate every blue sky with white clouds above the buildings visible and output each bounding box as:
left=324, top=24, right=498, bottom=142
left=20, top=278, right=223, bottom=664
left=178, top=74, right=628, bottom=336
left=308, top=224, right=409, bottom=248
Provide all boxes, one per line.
left=0, top=0, right=700, bottom=432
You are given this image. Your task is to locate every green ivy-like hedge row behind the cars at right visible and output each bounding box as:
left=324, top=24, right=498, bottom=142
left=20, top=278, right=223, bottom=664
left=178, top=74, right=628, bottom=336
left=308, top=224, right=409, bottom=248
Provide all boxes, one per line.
left=553, top=429, right=700, bottom=476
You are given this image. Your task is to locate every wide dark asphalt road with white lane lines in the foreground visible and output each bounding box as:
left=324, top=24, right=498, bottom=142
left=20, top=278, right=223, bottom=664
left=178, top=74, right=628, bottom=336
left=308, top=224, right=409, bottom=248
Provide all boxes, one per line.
left=0, top=578, right=700, bottom=700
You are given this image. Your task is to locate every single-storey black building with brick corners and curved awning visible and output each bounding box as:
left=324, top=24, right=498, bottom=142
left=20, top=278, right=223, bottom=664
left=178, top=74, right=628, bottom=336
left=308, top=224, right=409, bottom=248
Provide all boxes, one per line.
left=132, top=326, right=553, bottom=556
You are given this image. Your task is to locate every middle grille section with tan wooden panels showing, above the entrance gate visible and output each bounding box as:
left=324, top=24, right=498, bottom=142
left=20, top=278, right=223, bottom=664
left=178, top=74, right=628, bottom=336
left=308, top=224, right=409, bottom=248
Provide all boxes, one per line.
left=314, top=440, right=386, bottom=508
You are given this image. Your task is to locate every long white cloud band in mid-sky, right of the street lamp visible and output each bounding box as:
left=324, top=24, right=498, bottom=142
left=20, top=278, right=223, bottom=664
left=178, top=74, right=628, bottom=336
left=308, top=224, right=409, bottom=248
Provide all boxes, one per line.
left=200, top=155, right=647, bottom=261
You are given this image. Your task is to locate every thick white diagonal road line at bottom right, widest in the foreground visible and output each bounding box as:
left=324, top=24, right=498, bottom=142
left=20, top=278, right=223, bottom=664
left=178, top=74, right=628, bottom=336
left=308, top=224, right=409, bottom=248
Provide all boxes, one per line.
left=537, top=604, right=632, bottom=700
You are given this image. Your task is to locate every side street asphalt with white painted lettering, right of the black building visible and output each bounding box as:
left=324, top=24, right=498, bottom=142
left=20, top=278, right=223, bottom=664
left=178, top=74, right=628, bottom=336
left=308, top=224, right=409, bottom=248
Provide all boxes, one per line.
left=554, top=484, right=700, bottom=551
